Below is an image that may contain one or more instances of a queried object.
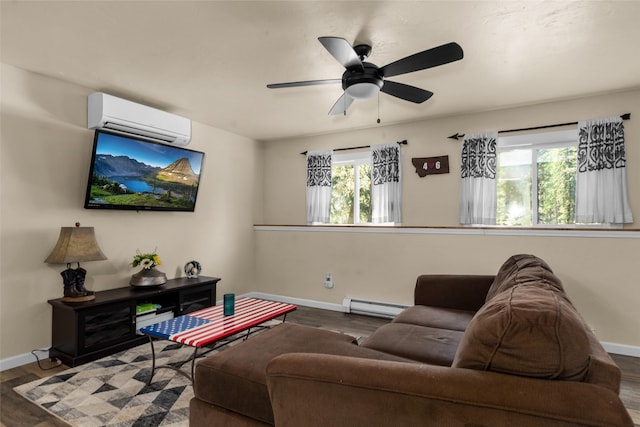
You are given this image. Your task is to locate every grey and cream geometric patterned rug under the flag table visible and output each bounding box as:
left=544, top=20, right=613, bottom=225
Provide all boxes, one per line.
left=14, top=328, right=272, bottom=427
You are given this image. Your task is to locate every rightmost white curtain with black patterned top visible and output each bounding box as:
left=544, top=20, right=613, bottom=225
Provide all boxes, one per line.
left=576, top=117, right=633, bottom=224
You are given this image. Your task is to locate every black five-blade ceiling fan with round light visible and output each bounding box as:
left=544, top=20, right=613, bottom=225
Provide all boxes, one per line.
left=267, top=37, right=463, bottom=115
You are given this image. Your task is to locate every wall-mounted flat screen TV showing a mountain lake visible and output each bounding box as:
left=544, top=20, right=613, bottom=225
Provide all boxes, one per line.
left=84, top=130, right=204, bottom=212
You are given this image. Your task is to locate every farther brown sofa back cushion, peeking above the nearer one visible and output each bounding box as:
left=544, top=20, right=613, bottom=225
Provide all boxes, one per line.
left=485, top=254, right=564, bottom=301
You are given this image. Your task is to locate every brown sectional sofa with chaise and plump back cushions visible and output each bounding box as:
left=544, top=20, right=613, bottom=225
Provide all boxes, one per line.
left=190, top=255, right=633, bottom=427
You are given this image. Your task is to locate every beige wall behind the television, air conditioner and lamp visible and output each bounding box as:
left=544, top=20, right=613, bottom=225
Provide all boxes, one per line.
left=0, top=65, right=262, bottom=359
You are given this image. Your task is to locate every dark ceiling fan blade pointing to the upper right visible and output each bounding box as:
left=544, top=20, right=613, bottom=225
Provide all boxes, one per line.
left=380, top=42, right=464, bottom=77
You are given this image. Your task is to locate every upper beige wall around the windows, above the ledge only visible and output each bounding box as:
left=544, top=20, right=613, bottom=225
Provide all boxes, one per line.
left=264, top=90, right=640, bottom=228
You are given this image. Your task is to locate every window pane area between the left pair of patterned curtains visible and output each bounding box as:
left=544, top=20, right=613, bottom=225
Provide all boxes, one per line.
left=330, top=151, right=371, bottom=224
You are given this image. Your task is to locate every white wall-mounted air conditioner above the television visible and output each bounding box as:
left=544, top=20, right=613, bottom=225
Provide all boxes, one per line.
left=87, top=92, right=191, bottom=146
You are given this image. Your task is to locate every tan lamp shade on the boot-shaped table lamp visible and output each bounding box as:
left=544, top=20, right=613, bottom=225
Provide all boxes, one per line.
left=44, top=223, right=107, bottom=264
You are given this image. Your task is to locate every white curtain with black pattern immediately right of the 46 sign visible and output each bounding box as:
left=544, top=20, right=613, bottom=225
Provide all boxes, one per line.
left=460, top=132, right=498, bottom=225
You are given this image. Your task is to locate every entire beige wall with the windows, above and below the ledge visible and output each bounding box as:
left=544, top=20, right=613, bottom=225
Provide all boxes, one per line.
left=256, top=90, right=640, bottom=354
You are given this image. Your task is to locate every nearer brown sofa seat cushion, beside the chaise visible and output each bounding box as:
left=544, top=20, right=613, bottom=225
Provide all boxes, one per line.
left=362, top=323, right=463, bottom=366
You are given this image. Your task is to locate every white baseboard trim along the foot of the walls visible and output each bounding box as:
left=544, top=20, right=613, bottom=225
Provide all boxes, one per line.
left=0, top=298, right=640, bottom=372
